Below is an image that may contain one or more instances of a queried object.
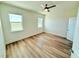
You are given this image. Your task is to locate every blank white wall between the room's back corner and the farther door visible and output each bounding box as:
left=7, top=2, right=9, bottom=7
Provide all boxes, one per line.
left=45, top=11, right=68, bottom=37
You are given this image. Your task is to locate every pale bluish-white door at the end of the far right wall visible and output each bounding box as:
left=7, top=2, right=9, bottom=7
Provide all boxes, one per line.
left=67, top=17, right=76, bottom=41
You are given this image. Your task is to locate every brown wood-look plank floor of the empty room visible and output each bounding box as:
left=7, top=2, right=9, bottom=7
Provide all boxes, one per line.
left=6, top=33, right=72, bottom=58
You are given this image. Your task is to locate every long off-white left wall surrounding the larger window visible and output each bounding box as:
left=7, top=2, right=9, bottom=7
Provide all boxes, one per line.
left=0, top=4, right=44, bottom=44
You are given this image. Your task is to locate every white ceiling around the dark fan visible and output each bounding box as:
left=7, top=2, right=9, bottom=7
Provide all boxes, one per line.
left=0, top=1, right=78, bottom=13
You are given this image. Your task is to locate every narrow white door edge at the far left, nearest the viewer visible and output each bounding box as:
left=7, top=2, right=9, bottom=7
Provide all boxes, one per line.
left=0, top=21, right=5, bottom=58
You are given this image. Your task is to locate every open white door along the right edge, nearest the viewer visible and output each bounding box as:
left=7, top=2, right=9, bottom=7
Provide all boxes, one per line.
left=71, top=9, right=79, bottom=58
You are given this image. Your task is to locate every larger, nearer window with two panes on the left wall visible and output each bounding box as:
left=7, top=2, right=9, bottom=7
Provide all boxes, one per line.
left=9, top=14, right=23, bottom=32
